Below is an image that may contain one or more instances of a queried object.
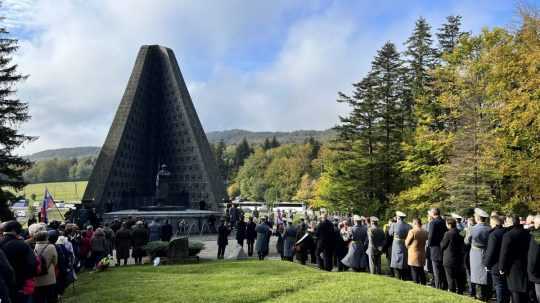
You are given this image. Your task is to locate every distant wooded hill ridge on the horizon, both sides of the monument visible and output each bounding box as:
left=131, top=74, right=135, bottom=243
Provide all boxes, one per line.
left=28, top=129, right=336, bottom=161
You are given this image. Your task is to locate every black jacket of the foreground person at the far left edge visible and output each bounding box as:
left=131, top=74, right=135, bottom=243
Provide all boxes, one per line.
left=0, top=234, right=36, bottom=291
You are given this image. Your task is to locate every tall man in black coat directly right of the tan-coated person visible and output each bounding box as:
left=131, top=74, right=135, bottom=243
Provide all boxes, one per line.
left=427, top=208, right=447, bottom=289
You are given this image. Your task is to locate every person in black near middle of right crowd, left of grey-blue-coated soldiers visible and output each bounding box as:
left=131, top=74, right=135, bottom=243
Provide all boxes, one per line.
left=316, top=214, right=336, bottom=271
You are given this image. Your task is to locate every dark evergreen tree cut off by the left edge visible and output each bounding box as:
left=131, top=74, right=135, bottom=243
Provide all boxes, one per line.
left=0, top=17, right=33, bottom=221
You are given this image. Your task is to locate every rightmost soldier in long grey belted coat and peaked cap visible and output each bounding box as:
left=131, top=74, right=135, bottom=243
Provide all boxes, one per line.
left=467, top=208, right=491, bottom=301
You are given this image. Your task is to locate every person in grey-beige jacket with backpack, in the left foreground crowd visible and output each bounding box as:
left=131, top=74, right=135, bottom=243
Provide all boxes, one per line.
left=33, top=231, right=58, bottom=303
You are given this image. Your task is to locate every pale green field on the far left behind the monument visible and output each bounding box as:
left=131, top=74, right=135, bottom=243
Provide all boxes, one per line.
left=7, top=181, right=88, bottom=202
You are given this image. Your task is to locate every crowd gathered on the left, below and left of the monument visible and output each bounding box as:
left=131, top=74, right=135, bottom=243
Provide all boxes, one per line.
left=0, top=217, right=173, bottom=303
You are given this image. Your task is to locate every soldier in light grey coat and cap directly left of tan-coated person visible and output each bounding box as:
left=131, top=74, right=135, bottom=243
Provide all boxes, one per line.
left=389, top=211, right=411, bottom=280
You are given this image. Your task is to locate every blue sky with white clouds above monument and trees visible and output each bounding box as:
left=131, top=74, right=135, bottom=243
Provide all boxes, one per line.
left=0, top=0, right=518, bottom=154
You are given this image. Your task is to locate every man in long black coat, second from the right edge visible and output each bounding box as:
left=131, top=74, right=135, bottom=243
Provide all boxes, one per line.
left=499, top=216, right=530, bottom=303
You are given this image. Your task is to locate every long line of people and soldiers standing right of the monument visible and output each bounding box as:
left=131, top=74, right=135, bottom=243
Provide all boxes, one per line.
left=218, top=208, right=540, bottom=303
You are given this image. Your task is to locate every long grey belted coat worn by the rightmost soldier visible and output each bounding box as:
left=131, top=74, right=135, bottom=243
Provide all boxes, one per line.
left=469, top=223, right=491, bottom=285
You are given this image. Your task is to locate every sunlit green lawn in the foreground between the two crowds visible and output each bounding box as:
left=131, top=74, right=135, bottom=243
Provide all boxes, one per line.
left=64, top=260, right=477, bottom=303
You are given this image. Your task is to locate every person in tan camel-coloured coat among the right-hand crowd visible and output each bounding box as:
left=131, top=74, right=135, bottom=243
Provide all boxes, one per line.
left=405, top=218, right=428, bottom=285
